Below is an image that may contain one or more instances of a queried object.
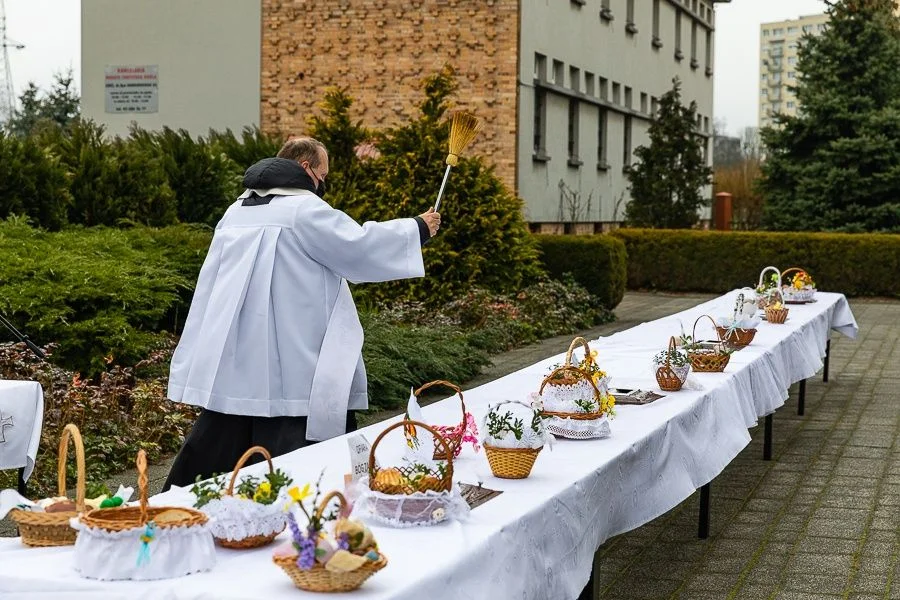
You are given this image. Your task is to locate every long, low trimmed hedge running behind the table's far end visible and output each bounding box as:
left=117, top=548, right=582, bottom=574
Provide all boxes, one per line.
left=612, top=229, right=900, bottom=296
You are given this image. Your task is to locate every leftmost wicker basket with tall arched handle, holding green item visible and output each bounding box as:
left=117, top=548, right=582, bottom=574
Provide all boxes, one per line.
left=9, top=423, right=84, bottom=546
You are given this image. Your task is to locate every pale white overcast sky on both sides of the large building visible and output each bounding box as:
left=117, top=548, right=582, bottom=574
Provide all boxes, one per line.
left=5, top=0, right=825, bottom=134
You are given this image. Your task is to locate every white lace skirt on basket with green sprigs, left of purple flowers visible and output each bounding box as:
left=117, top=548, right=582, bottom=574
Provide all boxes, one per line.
left=200, top=494, right=287, bottom=542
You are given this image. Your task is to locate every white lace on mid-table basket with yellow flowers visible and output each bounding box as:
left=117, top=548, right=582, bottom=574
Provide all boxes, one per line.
left=541, top=376, right=612, bottom=440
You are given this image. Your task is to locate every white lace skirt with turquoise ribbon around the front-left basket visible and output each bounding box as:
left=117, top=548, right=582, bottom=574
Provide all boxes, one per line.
left=70, top=517, right=216, bottom=581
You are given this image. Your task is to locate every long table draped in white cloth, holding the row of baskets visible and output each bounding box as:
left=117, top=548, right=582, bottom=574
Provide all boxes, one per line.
left=0, top=292, right=857, bottom=600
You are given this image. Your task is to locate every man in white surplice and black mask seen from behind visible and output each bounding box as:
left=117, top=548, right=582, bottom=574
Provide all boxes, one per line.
left=163, top=138, right=441, bottom=489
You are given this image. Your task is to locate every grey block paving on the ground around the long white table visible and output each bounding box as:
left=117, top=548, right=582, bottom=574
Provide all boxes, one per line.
left=0, top=293, right=900, bottom=600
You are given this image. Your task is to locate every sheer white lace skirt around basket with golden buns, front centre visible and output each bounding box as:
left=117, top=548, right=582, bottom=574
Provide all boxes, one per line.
left=351, top=477, right=469, bottom=527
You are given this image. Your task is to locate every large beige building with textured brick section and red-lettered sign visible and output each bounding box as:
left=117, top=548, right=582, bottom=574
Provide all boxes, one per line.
left=82, top=0, right=715, bottom=232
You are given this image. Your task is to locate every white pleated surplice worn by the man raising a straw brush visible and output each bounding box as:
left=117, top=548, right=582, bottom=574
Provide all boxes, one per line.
left=168, top=189, right=425, bottom=440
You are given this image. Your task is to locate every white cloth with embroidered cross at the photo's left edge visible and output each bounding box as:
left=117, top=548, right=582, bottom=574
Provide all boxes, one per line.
left=0, top=379, right=44, bottom=480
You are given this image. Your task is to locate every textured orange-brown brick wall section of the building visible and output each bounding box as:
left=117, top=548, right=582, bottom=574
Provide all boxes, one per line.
left=260, top=0, right=519, bottom=189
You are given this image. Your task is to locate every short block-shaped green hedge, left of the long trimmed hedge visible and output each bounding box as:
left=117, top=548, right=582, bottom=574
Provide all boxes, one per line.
left=535, top=235, right=627, bottom=309
